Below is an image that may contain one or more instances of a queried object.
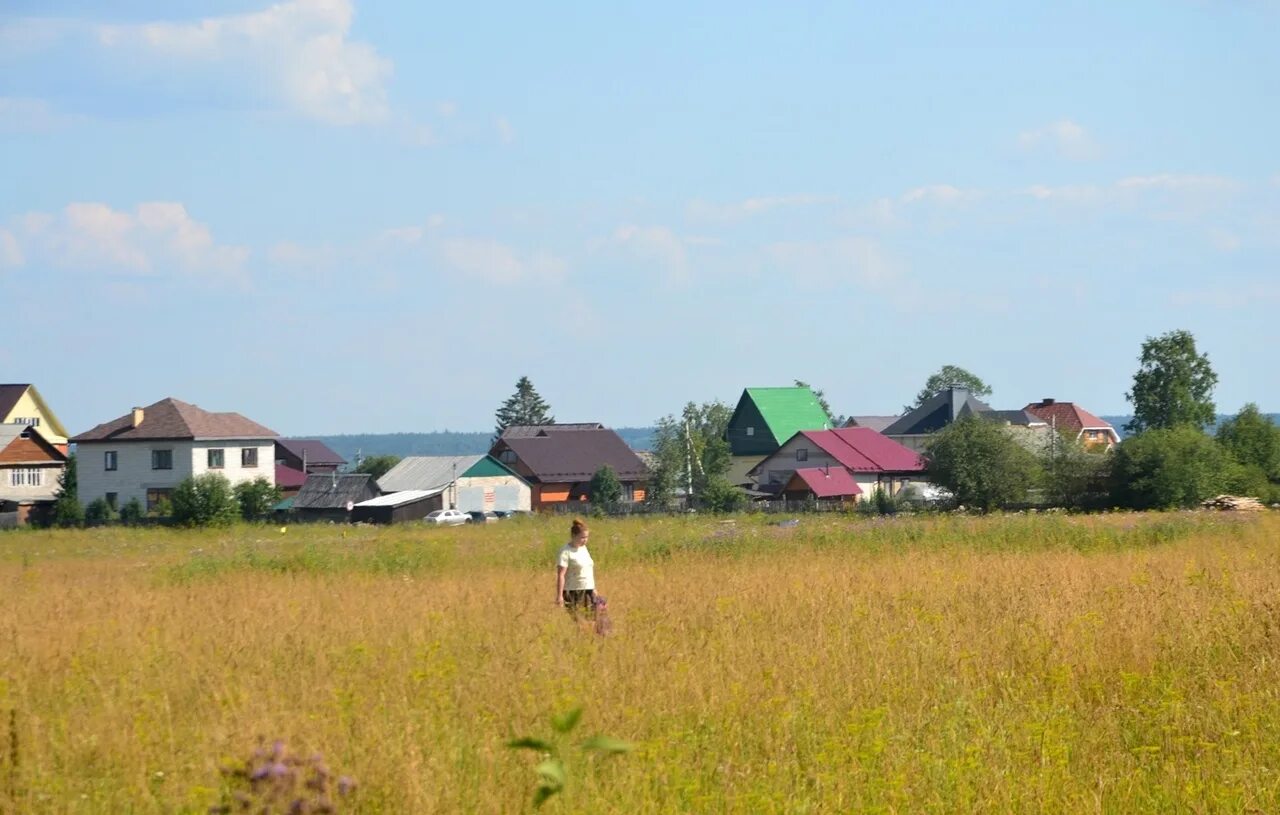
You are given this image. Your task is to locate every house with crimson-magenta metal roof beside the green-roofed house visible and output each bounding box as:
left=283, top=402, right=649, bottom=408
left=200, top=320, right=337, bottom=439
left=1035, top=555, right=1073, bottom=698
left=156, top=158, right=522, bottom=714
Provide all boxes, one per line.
left=750, top=427, right=925, bottom=502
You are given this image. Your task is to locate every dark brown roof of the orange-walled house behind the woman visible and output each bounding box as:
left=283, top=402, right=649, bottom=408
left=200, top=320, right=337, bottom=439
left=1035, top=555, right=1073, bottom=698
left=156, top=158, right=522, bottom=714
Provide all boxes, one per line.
left=490, top=427, right=649, bottom=484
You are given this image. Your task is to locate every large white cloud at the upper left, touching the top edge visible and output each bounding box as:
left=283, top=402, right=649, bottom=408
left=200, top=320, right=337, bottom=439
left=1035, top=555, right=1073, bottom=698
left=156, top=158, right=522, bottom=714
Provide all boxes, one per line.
left=96, top=0, right=392, bottom=124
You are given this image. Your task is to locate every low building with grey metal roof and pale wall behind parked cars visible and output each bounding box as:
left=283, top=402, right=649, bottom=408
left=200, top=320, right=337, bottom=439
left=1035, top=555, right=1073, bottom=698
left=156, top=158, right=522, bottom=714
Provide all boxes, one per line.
left=378, top=455, right=532, bottom=512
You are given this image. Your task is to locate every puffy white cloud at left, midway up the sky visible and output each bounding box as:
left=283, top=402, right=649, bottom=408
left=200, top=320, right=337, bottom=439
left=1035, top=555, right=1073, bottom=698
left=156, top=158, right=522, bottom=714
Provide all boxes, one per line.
left=4, top=201, right=248, bottom=283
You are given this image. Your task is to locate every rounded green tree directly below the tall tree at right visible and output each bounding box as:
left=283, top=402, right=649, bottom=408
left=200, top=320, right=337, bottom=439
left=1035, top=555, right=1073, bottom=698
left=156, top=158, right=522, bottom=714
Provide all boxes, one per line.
left=1112, top=423, right=1234, bottom=509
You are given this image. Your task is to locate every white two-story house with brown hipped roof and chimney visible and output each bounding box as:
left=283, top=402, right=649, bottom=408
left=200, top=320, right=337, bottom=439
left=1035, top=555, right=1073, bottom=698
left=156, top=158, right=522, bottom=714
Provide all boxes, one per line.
left=72, top=398, right=278, bottom=512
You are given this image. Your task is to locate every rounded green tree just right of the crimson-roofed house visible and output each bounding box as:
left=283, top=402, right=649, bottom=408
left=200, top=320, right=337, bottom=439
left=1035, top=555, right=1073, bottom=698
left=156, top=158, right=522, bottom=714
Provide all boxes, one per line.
left=927, top=415, right=1039, bottom=512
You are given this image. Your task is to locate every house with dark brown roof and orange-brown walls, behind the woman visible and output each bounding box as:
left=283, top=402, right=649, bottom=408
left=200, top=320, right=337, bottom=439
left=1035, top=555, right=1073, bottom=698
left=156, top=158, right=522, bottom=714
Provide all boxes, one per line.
left=489, top=425, right=649, bottom=510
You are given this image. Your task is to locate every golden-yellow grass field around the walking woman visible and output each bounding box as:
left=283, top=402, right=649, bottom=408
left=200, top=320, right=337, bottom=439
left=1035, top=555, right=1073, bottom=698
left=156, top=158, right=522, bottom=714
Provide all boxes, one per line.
left=0, top=513, right=1280, bottom=812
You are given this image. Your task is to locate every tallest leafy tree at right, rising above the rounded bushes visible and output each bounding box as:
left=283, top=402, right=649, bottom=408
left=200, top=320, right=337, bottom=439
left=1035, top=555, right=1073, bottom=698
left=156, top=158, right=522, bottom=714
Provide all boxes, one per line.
left=1125, top=331, right=1217, bottom=434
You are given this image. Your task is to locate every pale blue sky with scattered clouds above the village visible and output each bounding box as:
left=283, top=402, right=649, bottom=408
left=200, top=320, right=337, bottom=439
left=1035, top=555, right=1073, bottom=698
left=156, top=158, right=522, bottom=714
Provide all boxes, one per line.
left=0, top=0, right=1280, bottom=435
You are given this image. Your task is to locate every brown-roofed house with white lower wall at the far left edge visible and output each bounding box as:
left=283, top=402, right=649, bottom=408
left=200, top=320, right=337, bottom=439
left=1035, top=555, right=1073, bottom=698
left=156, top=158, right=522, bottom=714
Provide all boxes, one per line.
left=0, top=423, right=67, bottom=526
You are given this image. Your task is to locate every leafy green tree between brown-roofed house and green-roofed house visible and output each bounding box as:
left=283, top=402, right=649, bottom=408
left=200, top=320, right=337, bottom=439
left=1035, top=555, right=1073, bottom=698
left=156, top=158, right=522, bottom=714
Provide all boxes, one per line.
left=650, top=402, right=733, bottom=503
